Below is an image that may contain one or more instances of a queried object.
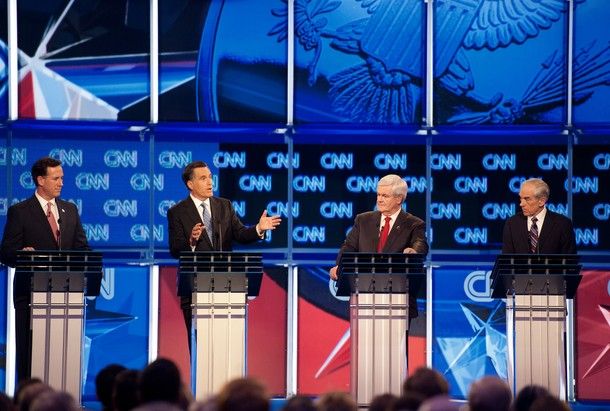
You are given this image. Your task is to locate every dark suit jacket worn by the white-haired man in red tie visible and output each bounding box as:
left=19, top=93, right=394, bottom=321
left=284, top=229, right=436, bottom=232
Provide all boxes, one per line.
left=337, top=210, right=428, bottom=264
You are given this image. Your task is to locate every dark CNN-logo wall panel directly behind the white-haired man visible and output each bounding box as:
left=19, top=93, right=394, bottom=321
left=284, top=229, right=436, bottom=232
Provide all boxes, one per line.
left=292, top=138, right=428, bottom=251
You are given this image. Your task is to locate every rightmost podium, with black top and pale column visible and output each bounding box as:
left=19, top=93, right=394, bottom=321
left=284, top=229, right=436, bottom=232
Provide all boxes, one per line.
left=491, top=254, right=582, bottom=399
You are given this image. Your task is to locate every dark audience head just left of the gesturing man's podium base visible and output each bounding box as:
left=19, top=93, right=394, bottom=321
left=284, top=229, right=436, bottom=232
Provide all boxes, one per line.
left=140, top=358, right=182, bottom=404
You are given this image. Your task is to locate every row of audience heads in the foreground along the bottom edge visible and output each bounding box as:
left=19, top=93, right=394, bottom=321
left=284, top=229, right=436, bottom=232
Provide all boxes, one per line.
left=0, top=358, right=570, bottom=411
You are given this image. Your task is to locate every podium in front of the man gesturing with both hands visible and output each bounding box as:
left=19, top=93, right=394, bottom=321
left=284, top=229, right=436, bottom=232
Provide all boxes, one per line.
left=178, top=251, right=263, bottom=399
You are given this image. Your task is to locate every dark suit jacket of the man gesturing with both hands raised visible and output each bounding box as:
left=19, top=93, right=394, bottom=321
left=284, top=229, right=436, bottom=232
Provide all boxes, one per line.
left=167, top=196, right=260, bottom=258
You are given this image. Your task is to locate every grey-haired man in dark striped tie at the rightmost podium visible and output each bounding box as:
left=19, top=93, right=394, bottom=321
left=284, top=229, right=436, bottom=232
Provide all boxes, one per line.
left=502, top=178, right=576, bottom=254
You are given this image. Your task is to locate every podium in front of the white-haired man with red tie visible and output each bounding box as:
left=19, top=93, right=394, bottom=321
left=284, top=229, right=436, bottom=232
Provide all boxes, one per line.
left=337, top=253, right=426, bottom=408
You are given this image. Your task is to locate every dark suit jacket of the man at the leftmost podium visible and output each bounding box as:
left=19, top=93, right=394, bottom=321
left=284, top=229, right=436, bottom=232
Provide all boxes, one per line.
left=0, top=196, right=89, bottom=297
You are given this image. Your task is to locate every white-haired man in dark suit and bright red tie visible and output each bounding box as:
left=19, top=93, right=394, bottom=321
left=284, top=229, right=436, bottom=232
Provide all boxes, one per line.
left=330, top=174, right=428, bottom=280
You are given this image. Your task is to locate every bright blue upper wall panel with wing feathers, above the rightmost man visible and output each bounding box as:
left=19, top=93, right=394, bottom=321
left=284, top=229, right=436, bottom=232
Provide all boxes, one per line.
left=434, top=1, right=568, bottom=125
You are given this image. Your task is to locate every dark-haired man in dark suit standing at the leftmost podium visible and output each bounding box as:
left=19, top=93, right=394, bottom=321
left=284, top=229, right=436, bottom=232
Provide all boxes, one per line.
left=0, top=157, right=89, bottom=379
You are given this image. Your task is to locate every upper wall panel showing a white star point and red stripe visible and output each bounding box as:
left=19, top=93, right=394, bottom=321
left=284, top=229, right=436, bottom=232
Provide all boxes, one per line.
left=17, top=0, right=150, bottom=120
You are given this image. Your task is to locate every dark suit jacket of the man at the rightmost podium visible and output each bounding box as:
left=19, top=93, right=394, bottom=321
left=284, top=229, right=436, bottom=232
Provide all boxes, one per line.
left=502, top=209, right=576, bottom=254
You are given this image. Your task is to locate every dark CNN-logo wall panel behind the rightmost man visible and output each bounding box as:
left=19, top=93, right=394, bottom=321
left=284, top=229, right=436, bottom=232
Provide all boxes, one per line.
left=429, top=141, right=569, bottom=250
